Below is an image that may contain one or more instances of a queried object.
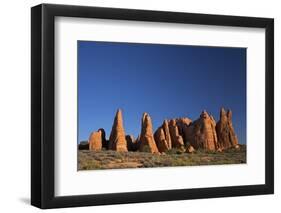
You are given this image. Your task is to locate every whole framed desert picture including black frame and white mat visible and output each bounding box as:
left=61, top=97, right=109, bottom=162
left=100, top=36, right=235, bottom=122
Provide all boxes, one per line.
left=31, top=4, right=274, bottom=208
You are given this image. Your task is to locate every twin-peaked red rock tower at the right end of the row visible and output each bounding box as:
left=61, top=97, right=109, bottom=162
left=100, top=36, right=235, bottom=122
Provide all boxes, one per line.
left=216, top=108, right=239, bottom=150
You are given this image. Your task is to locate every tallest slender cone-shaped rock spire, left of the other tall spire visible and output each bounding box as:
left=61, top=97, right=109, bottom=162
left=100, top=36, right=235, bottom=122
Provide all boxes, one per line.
left=108, top=109, right=128, bottom=152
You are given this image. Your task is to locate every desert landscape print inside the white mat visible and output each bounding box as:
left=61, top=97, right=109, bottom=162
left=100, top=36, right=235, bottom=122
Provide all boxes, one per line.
left=78, top=41, right=246, bottom=170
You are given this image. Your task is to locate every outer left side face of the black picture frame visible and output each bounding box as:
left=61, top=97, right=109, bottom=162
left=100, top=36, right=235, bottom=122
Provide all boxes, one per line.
left=31, top=5, right=43, bottom=208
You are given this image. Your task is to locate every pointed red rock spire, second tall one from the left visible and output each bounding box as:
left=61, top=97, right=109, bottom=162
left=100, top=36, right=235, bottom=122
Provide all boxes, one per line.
left=139, top=113, right=159, bottom=153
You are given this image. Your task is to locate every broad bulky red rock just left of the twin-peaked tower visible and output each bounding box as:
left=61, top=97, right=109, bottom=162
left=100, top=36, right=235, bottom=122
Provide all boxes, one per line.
left=185, top=111, right=218, bottom=150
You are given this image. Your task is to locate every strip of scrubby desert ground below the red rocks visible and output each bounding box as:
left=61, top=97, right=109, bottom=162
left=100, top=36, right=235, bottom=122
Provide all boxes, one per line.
left=78, top=145, right=246, bottom=170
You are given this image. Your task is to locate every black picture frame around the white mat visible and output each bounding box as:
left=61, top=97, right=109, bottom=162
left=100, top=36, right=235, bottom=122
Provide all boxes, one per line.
left=31, top=4, right=274, bottom=209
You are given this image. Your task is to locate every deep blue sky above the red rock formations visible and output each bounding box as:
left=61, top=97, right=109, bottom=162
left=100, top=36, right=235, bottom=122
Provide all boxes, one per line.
left=78, top=41, right=246, bottom=143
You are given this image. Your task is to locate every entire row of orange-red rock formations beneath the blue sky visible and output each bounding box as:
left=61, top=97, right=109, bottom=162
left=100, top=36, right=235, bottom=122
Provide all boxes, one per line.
left=78, top=108, right=239, bottom=153
